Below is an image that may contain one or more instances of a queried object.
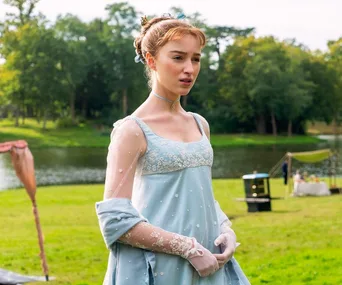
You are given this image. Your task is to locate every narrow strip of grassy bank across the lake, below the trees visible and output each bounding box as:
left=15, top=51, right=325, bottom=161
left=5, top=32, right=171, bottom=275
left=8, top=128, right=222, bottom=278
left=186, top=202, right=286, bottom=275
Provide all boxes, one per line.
left=0, top=119, right=321, bottom=148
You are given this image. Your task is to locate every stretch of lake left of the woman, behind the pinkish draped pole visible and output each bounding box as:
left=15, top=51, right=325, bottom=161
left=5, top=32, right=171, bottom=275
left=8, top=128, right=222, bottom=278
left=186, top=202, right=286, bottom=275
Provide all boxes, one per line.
left=0, top=148, right=107, bottom=190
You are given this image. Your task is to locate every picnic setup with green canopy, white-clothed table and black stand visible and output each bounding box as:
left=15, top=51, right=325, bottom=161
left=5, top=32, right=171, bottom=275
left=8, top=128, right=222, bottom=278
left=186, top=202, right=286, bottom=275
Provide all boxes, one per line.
left=236, top=149, right=342, bottom=212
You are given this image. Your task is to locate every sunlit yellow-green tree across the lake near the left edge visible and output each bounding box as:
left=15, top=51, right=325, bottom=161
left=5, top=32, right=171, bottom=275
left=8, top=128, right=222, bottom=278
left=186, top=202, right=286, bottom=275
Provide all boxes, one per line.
left=3, top=21, right=66, bottom=128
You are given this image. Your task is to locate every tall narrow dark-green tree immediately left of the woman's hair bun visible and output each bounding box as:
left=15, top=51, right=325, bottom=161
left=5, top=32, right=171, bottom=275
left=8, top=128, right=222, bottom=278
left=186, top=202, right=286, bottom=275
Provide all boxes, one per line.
left=103, top=2, right=146, bottom=116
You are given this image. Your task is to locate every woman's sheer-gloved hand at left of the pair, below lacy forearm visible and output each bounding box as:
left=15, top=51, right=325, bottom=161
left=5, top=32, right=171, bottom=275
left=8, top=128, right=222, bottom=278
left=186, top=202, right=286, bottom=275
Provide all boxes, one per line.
left=183, top=238, right=219, bottom=277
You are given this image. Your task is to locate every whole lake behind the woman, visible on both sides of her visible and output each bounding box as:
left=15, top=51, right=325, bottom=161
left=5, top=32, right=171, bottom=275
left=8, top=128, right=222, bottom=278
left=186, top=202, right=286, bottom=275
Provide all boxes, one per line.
left=0, top=138, right=336, bottom=190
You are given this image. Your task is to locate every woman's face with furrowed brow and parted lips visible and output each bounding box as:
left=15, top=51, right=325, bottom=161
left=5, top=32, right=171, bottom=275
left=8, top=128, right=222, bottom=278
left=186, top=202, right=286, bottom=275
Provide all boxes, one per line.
left=154, top=35, right=201, bottom=96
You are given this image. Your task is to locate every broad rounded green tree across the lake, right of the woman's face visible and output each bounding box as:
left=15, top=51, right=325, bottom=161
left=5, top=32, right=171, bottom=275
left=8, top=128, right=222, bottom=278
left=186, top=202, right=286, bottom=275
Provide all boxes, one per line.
left=220, top=36, right=310, bottom=135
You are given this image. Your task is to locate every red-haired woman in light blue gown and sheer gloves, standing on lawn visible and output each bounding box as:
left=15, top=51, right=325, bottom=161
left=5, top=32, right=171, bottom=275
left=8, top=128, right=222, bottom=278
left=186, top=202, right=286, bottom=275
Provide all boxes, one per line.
left=96, top=13, right=249, bottom=285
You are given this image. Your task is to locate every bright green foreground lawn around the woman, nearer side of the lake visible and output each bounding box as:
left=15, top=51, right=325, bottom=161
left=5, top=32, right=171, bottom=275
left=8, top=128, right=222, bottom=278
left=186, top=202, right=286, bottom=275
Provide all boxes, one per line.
left=0, top=179, right=342, bottom=285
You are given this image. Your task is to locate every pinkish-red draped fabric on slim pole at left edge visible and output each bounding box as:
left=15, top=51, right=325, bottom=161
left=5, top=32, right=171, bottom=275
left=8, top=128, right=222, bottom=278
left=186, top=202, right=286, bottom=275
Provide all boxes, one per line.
left=0, top=140, right=49, bottom=281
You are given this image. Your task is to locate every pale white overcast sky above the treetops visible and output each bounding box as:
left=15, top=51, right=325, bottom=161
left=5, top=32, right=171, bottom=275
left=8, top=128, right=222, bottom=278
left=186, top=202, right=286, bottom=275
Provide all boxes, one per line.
left=0, top=0, right=342, bottom=51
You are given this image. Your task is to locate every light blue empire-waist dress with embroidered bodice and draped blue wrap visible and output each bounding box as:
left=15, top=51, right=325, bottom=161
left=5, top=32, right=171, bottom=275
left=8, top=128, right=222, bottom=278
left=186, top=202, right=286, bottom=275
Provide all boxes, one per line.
left=96, top=114, right=250, bottom=285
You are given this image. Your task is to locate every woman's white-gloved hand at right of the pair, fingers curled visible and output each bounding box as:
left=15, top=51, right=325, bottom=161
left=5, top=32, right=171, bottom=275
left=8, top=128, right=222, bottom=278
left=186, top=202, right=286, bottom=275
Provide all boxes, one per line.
left=214, top=227, right=240, bottom=268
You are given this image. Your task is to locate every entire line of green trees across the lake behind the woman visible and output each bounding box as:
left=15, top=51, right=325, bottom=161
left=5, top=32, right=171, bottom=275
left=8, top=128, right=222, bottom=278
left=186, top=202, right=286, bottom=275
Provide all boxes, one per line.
left=0, top=0, right=342, bottom=135
